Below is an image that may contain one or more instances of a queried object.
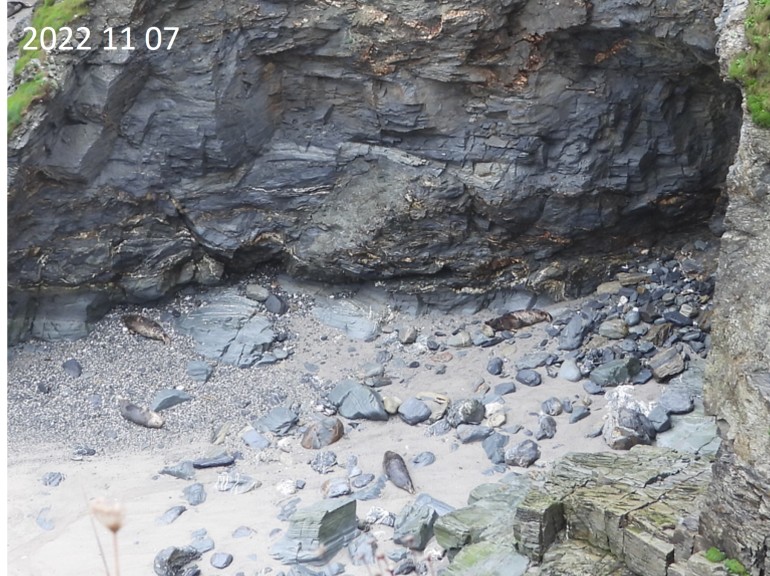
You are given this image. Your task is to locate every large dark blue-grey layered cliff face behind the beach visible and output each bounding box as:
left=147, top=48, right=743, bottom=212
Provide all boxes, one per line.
left=9, top=0, right=740, bottom=338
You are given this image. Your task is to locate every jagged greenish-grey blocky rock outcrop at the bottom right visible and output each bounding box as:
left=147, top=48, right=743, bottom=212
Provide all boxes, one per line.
left=435, top=445, right=711, bottom=576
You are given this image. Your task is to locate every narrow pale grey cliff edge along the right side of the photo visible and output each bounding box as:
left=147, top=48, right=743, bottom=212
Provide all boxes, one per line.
left=701, top=1, right=770, bottom=574
